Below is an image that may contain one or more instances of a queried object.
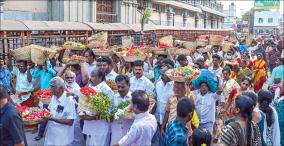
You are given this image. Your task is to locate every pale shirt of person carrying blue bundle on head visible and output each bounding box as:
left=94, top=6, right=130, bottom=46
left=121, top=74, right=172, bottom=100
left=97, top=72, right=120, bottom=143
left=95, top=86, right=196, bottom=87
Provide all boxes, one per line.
left=193, top=90, right=223, bottom=124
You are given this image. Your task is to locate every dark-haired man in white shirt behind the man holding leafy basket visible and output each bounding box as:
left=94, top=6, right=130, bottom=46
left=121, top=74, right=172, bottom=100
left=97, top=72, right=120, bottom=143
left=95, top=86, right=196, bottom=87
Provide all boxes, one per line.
left=97, top=56, right=118, bottom=82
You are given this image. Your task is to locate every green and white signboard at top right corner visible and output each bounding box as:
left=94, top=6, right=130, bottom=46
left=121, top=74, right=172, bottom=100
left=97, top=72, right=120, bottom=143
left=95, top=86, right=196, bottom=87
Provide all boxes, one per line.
left=254, top=0, right=280, bottom=10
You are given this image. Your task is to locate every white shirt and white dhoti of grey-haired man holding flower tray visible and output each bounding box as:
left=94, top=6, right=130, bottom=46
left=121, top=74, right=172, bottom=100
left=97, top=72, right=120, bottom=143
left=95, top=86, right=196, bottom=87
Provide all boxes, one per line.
left=44, top=92, right=76, bottom=145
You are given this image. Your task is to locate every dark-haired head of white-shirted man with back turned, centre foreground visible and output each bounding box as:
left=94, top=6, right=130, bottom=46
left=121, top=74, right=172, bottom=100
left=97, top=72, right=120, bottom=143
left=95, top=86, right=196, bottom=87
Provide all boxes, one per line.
left=131, top=90, right=150, bottom=114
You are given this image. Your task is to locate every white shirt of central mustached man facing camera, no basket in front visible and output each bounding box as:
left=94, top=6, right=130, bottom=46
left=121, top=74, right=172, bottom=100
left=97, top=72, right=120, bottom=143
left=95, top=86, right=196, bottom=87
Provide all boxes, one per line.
left=130, top=75, right=155, bottom=94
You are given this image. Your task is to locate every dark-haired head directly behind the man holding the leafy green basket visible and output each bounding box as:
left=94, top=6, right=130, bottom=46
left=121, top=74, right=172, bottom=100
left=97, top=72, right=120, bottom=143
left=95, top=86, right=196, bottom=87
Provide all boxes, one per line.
left=97, top=56, right=112, bottom=74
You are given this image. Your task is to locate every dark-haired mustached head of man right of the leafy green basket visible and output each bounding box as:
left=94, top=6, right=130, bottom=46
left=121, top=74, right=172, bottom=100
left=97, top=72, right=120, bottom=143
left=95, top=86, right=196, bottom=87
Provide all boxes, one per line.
left=115, top=75, right=130, bottom=97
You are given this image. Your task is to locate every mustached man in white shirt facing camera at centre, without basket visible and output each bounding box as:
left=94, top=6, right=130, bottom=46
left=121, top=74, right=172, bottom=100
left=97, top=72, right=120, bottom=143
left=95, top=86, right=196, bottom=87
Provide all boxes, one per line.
left=130, top=60, right=155, bottom=94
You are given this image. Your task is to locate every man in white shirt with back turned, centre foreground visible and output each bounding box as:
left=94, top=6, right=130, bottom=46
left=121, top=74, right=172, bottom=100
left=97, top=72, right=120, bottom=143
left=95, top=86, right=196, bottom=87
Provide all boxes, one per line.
left=114, top=90, right=157, bottom=146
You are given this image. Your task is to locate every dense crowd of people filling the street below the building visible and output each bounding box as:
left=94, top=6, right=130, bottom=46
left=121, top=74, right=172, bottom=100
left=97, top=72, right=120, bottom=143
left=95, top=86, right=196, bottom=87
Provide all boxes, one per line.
left=0, top=34, right=284, bottom=146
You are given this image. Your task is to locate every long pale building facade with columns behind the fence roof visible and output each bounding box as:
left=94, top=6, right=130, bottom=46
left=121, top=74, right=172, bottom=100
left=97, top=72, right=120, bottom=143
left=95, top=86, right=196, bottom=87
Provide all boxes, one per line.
left=0, top=0, right=225, bottom=29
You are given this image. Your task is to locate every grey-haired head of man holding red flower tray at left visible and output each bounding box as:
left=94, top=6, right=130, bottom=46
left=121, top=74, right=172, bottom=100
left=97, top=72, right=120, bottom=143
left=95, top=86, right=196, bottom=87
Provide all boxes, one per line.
left=49, top=77, right=65, bottom=98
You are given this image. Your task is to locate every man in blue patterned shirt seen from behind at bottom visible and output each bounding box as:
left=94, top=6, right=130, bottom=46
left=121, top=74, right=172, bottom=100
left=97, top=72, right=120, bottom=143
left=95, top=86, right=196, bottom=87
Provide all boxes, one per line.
left=164, top=97, right=195, bottom=146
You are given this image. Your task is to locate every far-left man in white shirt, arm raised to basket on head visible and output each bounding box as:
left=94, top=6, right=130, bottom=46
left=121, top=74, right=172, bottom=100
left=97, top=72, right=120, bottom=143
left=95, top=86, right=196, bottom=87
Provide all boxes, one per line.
left=12, top=60, right=33, bottom=106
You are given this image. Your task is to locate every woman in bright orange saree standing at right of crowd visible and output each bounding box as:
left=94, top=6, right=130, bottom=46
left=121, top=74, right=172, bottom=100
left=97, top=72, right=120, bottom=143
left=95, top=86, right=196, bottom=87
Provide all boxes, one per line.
left=253, top=54, right=266, bottom=93
